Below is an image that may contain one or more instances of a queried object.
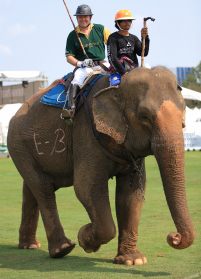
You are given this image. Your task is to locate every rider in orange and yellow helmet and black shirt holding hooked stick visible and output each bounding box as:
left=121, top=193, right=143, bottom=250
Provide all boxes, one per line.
left=107, top=10, right=149, bottom=78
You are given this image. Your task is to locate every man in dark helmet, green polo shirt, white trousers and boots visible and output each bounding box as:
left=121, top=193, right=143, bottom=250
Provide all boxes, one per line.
left=65, top=5, right=111, bottom=120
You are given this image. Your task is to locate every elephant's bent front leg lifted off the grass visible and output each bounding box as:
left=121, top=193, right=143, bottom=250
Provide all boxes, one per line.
left=74, top=168, right=116, bottom=253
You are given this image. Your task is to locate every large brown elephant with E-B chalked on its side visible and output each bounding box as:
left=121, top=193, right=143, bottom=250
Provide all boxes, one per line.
left=8, top=66, right=195, bottom=265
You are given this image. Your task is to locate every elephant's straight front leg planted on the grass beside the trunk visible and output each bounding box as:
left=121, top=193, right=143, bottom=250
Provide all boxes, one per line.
left=114, top=160, right=147, bottom=265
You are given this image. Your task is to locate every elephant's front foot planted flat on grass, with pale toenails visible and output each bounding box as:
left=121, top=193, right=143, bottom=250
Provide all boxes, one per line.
left=114, top=250, right=147, bottom=265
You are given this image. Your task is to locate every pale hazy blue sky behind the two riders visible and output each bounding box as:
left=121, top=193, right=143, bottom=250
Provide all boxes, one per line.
left=0, top=0, right=201, bottom=84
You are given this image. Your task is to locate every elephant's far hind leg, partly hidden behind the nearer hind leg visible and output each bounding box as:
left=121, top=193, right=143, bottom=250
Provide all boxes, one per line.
left=18, top=182, right=40, bottom=249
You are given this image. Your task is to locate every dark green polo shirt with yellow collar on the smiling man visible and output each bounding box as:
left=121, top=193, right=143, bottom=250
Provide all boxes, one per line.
left=65, top=23, right=110, bottom=61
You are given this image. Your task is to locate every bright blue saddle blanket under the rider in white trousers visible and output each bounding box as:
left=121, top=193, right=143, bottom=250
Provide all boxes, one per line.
left=40, top=73, right=109, bottom=109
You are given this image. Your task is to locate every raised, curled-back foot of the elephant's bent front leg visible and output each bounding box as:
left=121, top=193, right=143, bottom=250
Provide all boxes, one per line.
left=78, top=224, right=101, bottom=253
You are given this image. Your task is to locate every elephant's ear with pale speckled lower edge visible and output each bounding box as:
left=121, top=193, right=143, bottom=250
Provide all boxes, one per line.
left=92, top=86, right=127, bottom=144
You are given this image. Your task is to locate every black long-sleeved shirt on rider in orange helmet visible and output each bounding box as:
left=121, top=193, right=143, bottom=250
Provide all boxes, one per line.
left=107, top=32, right=149, bottom=75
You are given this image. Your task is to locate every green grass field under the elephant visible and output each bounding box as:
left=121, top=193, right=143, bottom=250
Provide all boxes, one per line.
left=0, top=151, right=201, bottom=279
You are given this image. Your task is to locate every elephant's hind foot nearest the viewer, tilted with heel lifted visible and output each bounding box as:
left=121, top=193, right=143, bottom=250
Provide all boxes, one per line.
left=49, top=237, right=76, bottom=258
